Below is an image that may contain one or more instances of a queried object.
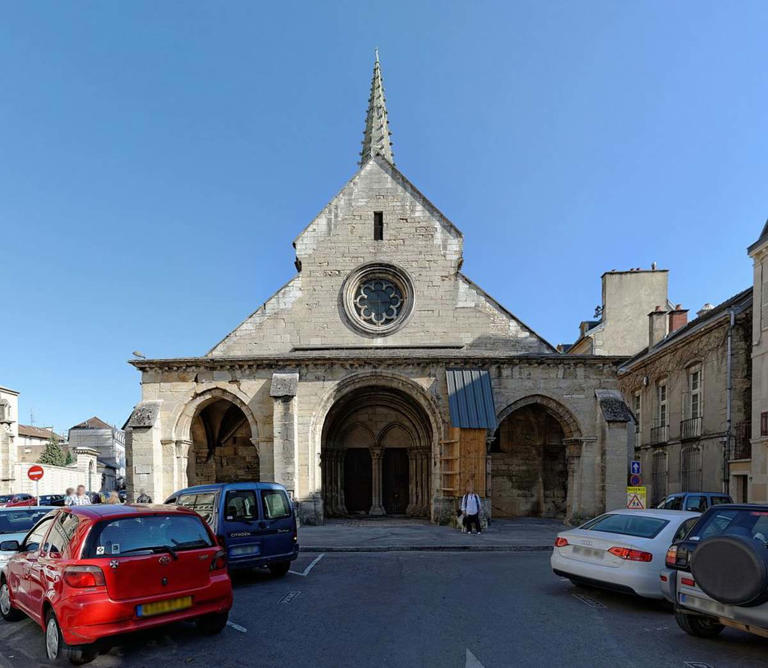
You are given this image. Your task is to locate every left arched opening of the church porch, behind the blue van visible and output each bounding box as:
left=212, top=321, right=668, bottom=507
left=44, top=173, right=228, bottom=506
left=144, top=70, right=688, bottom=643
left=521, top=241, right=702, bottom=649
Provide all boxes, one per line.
left=187, top=397, right=259, bottom=485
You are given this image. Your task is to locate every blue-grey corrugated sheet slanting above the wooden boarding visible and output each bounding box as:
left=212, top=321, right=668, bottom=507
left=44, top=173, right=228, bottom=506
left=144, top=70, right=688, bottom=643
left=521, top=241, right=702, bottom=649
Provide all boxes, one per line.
left=445, top=369, right=497, bottom=430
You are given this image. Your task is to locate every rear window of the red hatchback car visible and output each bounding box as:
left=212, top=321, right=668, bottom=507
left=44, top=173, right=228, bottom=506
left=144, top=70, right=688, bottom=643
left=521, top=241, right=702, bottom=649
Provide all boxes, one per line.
left=83, top=514, right=213, bottom=559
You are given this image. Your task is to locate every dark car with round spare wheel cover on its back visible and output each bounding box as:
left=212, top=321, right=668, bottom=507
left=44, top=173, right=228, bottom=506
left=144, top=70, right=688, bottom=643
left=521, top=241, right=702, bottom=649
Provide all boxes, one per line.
left=659, top=504, right=768, bottom=638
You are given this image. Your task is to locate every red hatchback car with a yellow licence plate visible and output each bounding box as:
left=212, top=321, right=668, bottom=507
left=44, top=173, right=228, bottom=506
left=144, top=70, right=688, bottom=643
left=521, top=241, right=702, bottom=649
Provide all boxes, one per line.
left=0, top=504, right=232, bottom=664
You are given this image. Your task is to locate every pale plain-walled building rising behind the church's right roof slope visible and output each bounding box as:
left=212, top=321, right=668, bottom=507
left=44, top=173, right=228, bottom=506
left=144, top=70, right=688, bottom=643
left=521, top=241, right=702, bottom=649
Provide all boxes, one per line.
left=560, top=264, right=672, bottom=355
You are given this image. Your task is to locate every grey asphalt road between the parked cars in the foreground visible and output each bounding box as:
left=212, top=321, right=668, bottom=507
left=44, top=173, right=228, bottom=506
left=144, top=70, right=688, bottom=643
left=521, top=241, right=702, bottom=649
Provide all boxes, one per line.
left=0, top=552, right=768, bottom=668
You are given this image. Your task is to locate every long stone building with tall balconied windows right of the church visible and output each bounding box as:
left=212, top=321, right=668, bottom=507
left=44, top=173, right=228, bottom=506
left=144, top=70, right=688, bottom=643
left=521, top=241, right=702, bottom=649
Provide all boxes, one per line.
left=619, top=288, right=752, bottom=504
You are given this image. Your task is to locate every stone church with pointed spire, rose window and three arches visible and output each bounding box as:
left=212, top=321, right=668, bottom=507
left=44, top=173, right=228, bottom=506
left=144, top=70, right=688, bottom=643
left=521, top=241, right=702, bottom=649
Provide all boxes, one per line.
left=127, top=57, right=633, bottom=523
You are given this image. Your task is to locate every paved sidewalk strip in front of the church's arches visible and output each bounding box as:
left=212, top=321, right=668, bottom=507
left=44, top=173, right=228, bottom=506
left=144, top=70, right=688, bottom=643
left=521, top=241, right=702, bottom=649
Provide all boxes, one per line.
left=299, top=517, right=565, bottom=552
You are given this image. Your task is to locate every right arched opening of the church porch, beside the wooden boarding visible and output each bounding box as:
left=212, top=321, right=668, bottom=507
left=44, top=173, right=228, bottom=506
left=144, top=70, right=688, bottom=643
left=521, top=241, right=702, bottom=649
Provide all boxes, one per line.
left=491, top=400, right=578, bottom=517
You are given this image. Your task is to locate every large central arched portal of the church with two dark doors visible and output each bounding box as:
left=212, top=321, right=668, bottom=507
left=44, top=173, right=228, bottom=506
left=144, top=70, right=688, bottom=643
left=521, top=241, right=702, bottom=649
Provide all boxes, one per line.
left=321, top=386, right=432, bottom=517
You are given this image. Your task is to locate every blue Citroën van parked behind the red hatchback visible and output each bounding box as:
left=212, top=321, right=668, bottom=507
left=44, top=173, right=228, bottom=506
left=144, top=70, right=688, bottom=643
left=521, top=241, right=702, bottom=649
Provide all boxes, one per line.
left=165, top=482, right=299, bottom=577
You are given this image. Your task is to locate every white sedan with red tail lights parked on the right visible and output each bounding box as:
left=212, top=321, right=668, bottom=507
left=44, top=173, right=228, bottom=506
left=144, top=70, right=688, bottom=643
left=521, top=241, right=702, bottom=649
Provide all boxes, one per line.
left=551, top=509, right=699, bottom=598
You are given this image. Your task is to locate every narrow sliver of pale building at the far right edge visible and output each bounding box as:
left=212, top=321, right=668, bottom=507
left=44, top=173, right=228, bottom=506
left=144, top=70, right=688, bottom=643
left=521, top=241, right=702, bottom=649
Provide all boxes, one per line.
left=748, top=222, right=768, bottom=503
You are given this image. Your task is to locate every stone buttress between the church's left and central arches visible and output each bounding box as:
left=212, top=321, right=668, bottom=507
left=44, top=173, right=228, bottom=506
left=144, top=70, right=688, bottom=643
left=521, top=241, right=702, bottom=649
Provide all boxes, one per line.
left=269, top=372, right=301, bottom=503
